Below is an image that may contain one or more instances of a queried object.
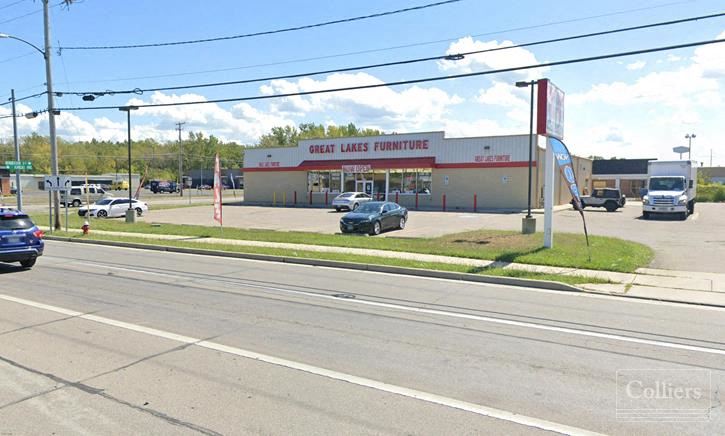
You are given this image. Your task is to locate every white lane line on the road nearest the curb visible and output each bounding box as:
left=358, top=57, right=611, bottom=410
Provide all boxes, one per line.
left=66, top=267, right=725, bottom=356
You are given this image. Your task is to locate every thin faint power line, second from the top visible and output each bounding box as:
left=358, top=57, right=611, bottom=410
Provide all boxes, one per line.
left=45, top=0, right=690, bottom=87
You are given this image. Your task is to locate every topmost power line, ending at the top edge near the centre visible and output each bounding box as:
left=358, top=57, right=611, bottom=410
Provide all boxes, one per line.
left=59, top=0, right=461, bottom=50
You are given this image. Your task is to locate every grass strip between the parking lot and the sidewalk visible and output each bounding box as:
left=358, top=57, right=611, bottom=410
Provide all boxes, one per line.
left=33, top=210, right=653, bottom=272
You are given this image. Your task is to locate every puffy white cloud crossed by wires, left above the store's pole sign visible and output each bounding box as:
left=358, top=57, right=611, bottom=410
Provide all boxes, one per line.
left=438, top=36, right=548, bottom=80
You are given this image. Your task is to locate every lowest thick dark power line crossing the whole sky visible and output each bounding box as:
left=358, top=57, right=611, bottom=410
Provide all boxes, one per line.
left=52, top=39, right=725, bottom=111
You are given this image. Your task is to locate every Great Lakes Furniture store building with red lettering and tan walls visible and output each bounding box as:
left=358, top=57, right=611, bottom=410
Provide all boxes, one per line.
left=243, top=132, right=591, bottom=210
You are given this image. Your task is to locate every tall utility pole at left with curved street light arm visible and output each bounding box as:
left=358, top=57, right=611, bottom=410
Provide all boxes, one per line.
left=0, top=0, right=60, bottom=230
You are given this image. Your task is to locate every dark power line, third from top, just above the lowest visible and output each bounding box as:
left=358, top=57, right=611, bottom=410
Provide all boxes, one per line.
left=56, top=12, right=725, bottom=96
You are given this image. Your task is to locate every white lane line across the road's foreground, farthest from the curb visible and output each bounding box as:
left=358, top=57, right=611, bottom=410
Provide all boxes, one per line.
left=0, top=294, right=600, bottom=435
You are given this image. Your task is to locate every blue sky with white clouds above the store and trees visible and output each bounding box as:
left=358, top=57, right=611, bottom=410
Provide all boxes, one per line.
left=0, top=0, right=725, bottom=166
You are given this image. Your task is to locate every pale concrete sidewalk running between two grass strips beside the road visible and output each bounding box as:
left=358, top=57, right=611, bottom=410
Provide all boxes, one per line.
left=44, top=229, right=725, bottom=307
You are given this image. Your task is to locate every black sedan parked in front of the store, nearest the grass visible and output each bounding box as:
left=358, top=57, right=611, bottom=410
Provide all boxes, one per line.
left=340, top=201, right=408, bottom=235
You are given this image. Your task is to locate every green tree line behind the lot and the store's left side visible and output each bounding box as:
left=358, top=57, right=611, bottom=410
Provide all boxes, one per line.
left=0, top=123, right=382, bottom=179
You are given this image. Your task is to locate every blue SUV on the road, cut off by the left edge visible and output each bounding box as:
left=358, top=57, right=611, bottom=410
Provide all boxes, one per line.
left=0, top=207, right=45, bottom=268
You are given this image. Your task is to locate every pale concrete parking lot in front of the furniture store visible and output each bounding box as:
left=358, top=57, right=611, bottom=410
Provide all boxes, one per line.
left=145, top=202, right=725, bottom=272
